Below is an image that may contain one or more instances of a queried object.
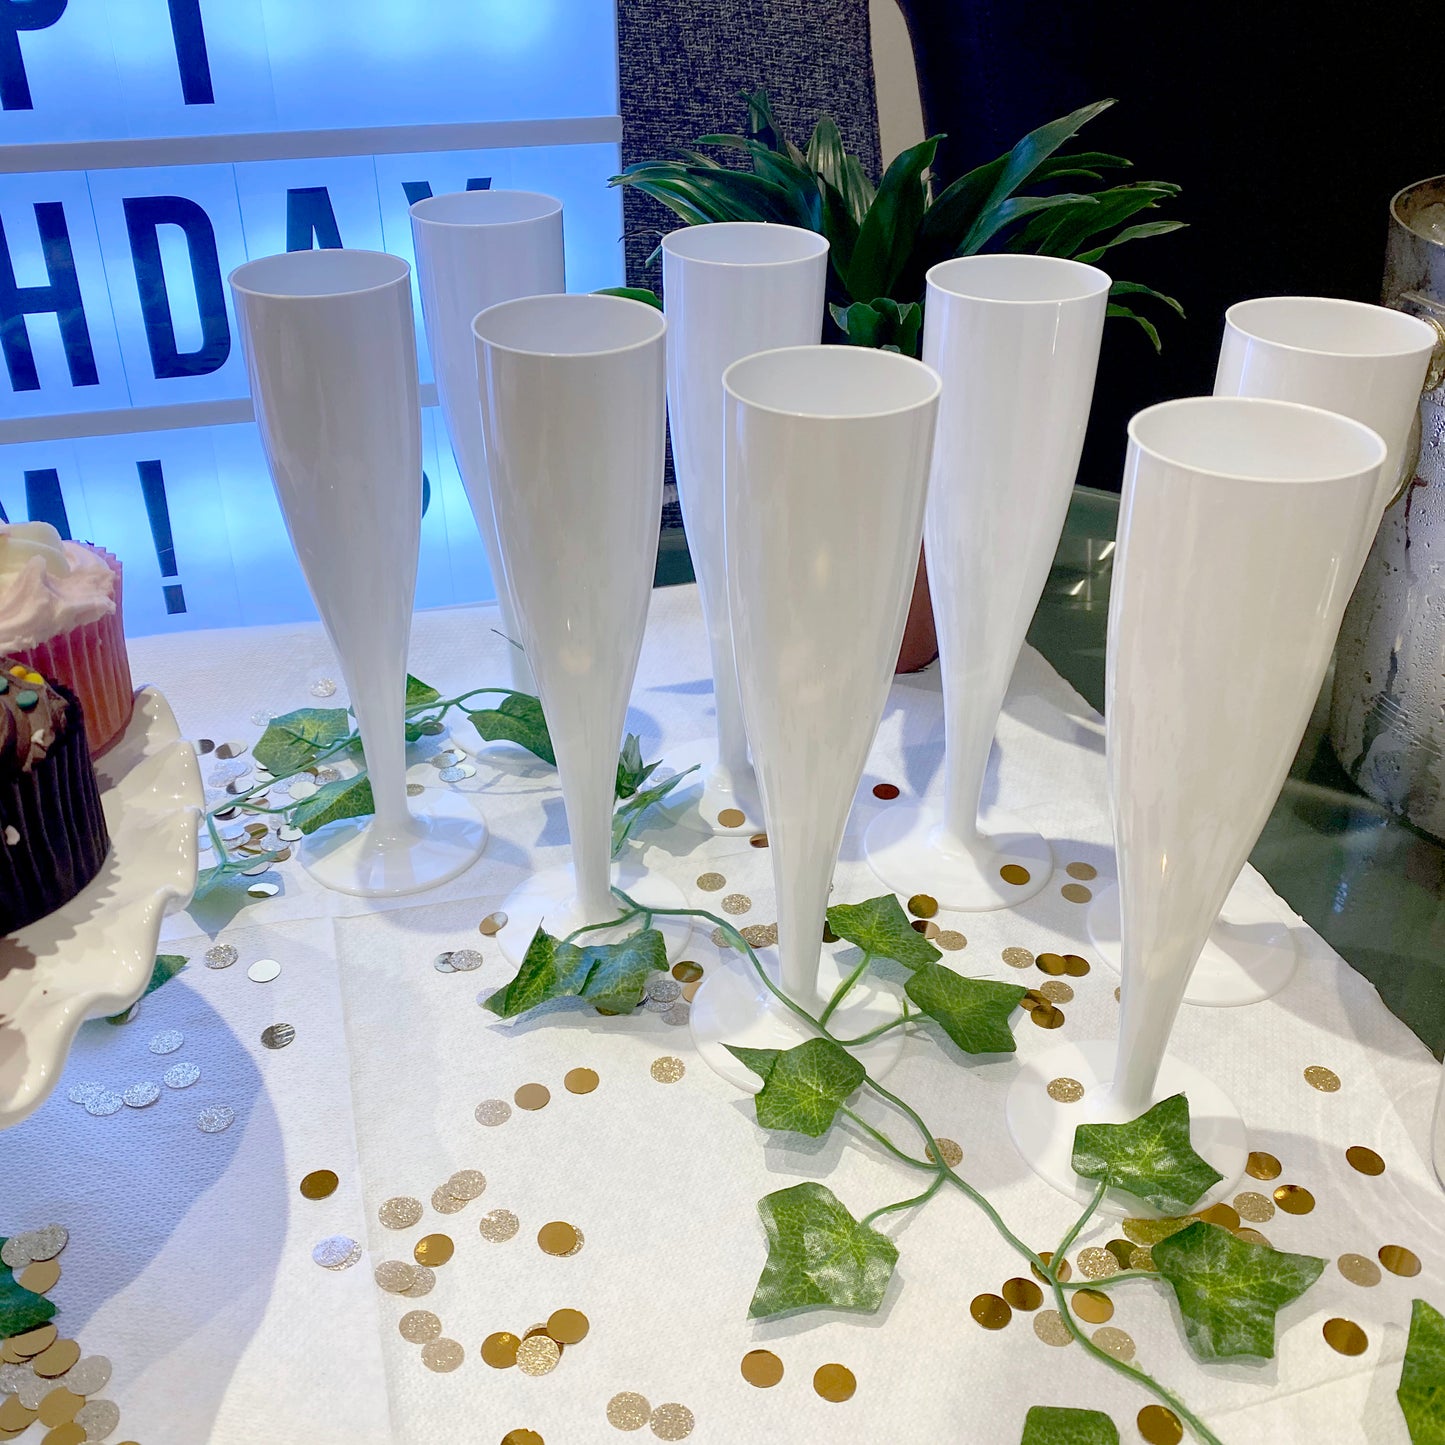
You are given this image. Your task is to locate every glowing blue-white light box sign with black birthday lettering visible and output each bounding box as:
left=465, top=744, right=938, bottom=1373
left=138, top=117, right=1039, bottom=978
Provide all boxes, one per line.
left=0, top=0, right=623, bottom=634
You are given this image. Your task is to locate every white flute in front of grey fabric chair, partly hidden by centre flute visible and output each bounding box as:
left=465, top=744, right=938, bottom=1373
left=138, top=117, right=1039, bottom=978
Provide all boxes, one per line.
left=662, top=221, right=828, bottom=834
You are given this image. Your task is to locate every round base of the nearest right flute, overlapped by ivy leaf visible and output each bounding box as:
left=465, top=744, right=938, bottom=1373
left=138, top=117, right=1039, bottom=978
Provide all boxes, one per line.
left=1004, top=1040, right=1248, bottom=1218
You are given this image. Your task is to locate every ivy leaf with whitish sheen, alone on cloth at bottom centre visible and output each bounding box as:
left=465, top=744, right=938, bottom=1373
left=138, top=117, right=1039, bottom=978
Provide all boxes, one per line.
left=747, top=1181, right=899, bottom=1319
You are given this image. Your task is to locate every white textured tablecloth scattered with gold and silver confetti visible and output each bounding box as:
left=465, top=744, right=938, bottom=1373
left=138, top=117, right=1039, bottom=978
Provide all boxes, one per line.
left=0, top=588, right=1445, bottom=1445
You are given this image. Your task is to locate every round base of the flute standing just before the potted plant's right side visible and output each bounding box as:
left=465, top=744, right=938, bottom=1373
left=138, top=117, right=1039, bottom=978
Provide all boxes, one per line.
left=863, top=803, right=1053, bottom=913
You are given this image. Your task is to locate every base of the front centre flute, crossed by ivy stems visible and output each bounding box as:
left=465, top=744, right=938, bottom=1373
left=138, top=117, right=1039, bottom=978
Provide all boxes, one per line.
left=688, top=948, right=903, bottom=1094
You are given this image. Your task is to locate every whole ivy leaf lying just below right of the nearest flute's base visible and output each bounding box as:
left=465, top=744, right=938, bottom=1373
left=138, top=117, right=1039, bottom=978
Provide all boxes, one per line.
left=1144, top=1225, right=1325, bottom=1360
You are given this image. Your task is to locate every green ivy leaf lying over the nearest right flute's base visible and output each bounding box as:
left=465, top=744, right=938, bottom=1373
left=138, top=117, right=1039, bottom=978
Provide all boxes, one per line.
left=1074, top=1094, right=1224, bottom=1214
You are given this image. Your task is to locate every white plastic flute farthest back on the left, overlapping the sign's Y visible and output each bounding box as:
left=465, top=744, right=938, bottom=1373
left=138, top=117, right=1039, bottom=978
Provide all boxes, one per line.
left=412, top=191, right=566, bottom=692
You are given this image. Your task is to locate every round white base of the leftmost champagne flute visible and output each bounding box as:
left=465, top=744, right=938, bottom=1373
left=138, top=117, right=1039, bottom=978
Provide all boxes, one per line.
left=301, top=789, right=487, bottom=899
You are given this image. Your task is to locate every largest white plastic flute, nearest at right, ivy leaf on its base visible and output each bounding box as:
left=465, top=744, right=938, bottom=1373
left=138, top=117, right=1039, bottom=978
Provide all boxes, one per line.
left=1007, top=396, right=1386, bottom=1212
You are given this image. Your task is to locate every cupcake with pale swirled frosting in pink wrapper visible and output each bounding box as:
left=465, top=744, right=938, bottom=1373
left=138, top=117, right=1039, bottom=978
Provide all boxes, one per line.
left=0, top=522, right=134, bottom=754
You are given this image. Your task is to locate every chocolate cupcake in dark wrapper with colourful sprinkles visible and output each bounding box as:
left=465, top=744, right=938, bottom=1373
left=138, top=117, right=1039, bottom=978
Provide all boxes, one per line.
left=0, top=657, right=110, bottom=933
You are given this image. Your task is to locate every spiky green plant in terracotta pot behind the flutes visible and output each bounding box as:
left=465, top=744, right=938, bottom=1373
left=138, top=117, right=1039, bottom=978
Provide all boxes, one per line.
left=611, top=91, right=1183, bottom=670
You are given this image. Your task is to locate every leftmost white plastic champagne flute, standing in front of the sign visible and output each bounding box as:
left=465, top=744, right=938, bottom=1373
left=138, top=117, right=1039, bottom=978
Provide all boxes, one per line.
left=231, top=250, right=487, bottom=897
